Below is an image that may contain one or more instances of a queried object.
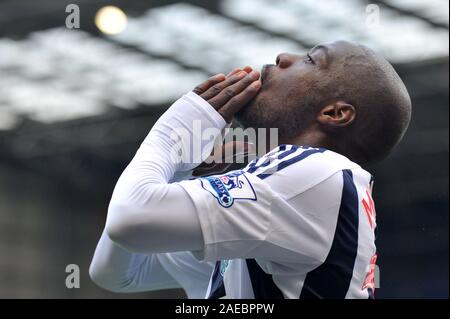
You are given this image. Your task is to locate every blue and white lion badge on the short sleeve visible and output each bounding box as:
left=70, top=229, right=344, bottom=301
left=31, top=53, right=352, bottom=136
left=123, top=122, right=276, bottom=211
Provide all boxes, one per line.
left=200, top=171, right=256, bottom=208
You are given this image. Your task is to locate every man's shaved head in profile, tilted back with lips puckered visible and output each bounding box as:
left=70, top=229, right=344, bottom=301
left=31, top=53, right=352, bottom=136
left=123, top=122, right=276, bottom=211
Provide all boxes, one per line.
left=236, top=41, right=411, bottom=163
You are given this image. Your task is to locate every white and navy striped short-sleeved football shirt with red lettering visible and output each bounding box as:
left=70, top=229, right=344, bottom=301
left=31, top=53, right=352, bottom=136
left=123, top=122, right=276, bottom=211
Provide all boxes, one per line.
left=174, top=145, right=376, bottom=298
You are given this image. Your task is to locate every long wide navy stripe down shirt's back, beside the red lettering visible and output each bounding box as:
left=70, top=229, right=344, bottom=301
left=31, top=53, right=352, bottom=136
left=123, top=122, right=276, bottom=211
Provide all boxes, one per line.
left=300, top=170, right=359, bottom=299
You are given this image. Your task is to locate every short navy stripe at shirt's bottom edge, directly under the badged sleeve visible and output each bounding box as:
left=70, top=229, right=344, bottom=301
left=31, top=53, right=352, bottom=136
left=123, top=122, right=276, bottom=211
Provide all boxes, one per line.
left=246, top=259, right=284, bottom=299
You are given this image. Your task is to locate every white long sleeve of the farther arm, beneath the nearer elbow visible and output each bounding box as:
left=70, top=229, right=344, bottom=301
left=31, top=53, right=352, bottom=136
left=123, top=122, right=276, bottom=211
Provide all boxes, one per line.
left=89, top=232, right=213, bottom=298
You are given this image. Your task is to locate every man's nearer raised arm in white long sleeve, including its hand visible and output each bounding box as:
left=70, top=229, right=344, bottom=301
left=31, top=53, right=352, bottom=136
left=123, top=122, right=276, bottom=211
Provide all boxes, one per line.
left=106, top=72, right=260, bottom=253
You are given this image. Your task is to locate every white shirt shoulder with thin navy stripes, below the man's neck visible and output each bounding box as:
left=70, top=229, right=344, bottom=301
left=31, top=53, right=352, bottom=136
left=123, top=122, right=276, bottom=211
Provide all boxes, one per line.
left=244, top=145, right=360, bottom=199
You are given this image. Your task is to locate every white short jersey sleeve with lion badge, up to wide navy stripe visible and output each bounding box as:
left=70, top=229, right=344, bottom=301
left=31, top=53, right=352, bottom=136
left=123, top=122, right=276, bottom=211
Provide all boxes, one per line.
left=180, top=151, right=360, bottom=267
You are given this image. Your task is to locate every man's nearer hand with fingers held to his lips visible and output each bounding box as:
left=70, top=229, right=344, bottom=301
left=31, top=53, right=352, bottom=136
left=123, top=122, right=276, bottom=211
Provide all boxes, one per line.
left=193, top=67, right=261, bottom=123
